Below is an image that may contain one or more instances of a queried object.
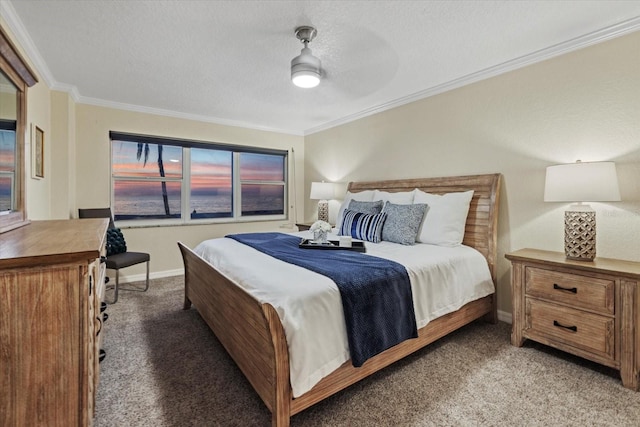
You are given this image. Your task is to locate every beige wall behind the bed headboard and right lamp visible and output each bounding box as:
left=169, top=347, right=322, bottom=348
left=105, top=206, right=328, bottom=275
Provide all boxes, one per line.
left=305, top=32, right=640, bottom=318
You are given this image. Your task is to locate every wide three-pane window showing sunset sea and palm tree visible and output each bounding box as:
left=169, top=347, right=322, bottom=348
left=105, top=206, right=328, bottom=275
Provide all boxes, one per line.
left=110, top=132, right=287, bottom=224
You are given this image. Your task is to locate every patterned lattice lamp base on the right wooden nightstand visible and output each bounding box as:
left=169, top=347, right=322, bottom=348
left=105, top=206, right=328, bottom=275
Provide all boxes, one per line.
left=564, top=210, right=596, bottom=261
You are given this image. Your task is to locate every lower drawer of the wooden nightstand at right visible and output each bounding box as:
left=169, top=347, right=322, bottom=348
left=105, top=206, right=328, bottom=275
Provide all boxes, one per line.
left=525, top=299, right=615, bottom=360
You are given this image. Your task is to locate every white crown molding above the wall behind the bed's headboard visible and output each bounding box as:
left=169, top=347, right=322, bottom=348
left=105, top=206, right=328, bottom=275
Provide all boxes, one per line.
left=304, top=16, right=640, bottom=136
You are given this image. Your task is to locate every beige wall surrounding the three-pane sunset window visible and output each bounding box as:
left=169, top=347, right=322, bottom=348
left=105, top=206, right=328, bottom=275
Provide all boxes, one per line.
left=73, top=104, right=304, bottom=280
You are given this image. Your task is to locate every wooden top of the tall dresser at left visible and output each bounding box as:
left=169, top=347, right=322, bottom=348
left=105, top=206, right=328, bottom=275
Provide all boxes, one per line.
left=0, top=218, right=109, bottom=269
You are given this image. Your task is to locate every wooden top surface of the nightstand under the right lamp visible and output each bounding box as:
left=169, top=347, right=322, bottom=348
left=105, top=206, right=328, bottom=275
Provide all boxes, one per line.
left=505, top=249, right=640, bottom=279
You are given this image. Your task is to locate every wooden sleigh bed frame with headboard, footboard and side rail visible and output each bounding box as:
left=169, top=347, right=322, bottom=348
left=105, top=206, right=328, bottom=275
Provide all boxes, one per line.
left=178, top=174, right=501, bottom=427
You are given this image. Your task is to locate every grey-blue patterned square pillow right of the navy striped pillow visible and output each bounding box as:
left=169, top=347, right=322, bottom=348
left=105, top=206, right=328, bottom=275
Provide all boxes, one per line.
left=382, top=202, right=427, bottom=245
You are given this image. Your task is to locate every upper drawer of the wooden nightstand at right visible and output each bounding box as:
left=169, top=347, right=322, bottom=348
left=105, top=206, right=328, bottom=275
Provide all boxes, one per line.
left=525, top=267, right=615, bottom=314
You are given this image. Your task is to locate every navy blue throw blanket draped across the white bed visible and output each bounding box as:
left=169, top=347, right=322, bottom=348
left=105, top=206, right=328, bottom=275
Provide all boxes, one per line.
left=226, top=233, right=418, bottom=367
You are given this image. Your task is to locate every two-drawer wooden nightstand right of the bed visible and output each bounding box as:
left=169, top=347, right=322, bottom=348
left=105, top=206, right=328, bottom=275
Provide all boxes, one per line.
left=505, top=249, right=640, bottom=391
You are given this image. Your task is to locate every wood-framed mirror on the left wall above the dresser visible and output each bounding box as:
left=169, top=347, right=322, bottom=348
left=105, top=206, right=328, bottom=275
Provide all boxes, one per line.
left=0, top=27, right=38, bottom=233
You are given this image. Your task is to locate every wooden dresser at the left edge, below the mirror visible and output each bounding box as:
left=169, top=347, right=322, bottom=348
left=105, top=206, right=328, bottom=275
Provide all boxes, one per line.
left=0, top=219, right=108, bottom=427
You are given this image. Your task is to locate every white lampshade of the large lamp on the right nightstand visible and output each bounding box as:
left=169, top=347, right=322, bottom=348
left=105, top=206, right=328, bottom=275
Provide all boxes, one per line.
left=544, top=161, right=620, bottom=202
